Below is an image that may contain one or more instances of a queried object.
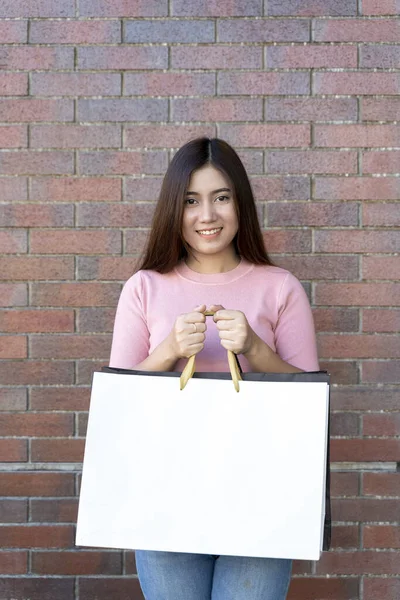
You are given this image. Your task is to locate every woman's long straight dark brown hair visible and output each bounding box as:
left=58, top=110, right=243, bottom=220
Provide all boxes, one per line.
left=138, top=137, right=272, bottom=273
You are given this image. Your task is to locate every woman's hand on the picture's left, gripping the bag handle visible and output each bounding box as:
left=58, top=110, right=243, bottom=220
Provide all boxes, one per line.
left=169, top=304, right=207, bottom=359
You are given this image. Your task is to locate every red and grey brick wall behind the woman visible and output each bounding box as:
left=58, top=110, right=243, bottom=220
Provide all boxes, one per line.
left=0, top=0, right=400, bottom=600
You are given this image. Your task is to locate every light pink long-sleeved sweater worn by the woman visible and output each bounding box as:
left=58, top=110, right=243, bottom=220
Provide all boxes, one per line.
left=110, top=260, right=318, bottom=372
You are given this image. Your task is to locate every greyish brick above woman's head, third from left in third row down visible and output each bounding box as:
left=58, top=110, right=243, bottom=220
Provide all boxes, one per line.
left=171, top=44, right=263, bottom=69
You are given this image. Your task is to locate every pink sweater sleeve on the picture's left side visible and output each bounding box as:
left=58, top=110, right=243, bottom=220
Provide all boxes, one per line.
left=110, top=271, right=150, bottom=369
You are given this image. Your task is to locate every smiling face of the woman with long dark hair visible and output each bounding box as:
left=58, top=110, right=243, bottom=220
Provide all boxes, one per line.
left=182, top=165, right=238, bottom=261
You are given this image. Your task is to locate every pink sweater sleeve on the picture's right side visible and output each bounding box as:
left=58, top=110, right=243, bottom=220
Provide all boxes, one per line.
left=275, top=273, right=319, bottom=371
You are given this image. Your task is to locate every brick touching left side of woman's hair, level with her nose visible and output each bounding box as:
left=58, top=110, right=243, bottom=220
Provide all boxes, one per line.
left=77, top=203, right=155, bottom=227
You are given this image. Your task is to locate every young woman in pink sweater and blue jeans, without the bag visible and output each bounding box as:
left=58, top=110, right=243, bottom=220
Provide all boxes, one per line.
left=110, top=138, right=318, bottom=600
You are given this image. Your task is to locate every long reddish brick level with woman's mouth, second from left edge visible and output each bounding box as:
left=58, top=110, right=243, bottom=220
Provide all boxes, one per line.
left=30, top=229, right=121, bottom=254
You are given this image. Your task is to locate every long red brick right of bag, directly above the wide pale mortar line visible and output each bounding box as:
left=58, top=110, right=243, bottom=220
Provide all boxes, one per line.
left=331, top=438, right=400, bottom=462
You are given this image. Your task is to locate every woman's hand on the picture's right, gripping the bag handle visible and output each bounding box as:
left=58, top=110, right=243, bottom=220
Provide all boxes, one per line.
left=210, top=305, right=256, bottom=354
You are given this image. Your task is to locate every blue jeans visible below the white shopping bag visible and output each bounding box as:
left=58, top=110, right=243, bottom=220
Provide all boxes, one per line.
left=136, top=550, right=292, bottom=600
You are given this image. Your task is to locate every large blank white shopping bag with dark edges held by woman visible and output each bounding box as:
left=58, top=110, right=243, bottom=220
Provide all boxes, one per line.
left=76, top=369, right=329, bottom=560
